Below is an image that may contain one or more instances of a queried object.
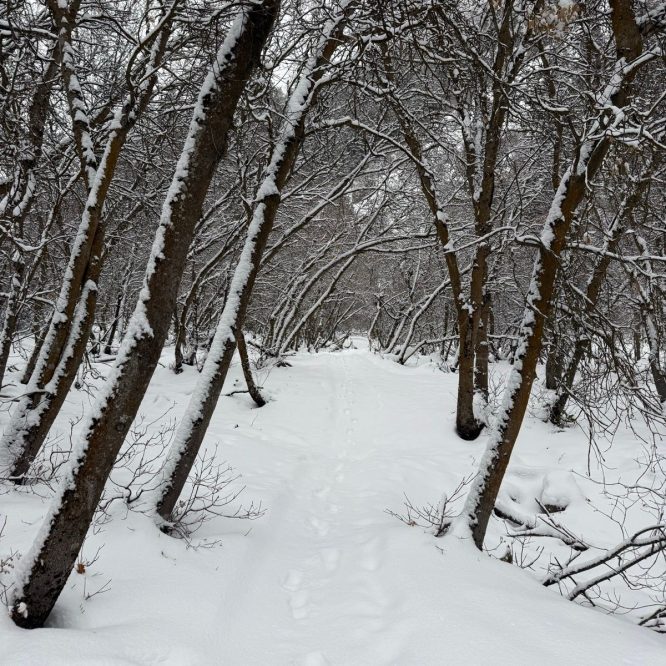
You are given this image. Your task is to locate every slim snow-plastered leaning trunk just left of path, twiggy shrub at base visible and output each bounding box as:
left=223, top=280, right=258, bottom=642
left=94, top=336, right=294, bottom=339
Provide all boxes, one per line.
left=154, top=7, right=350, bottom=521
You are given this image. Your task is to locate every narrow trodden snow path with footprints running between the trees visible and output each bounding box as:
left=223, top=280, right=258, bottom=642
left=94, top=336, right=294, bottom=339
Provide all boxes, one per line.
left=218, top=355, right=422, bottom=666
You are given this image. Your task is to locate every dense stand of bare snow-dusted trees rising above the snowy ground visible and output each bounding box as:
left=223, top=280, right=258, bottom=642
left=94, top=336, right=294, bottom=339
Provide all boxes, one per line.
left=0, top=0, right=666, bottom=627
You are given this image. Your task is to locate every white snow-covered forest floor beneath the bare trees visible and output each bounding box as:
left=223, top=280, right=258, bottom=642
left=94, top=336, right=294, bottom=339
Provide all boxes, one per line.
left=0, top=350, right=666, bottom=666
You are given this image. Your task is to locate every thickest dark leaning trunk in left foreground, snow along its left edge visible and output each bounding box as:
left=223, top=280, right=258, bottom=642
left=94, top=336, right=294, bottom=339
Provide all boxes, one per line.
left=11, top=0, right=279, bottom=628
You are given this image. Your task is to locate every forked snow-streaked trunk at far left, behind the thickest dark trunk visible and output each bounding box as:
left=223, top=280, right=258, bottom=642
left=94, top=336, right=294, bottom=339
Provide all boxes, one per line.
left=0, top=3, right=172, bottom=483
